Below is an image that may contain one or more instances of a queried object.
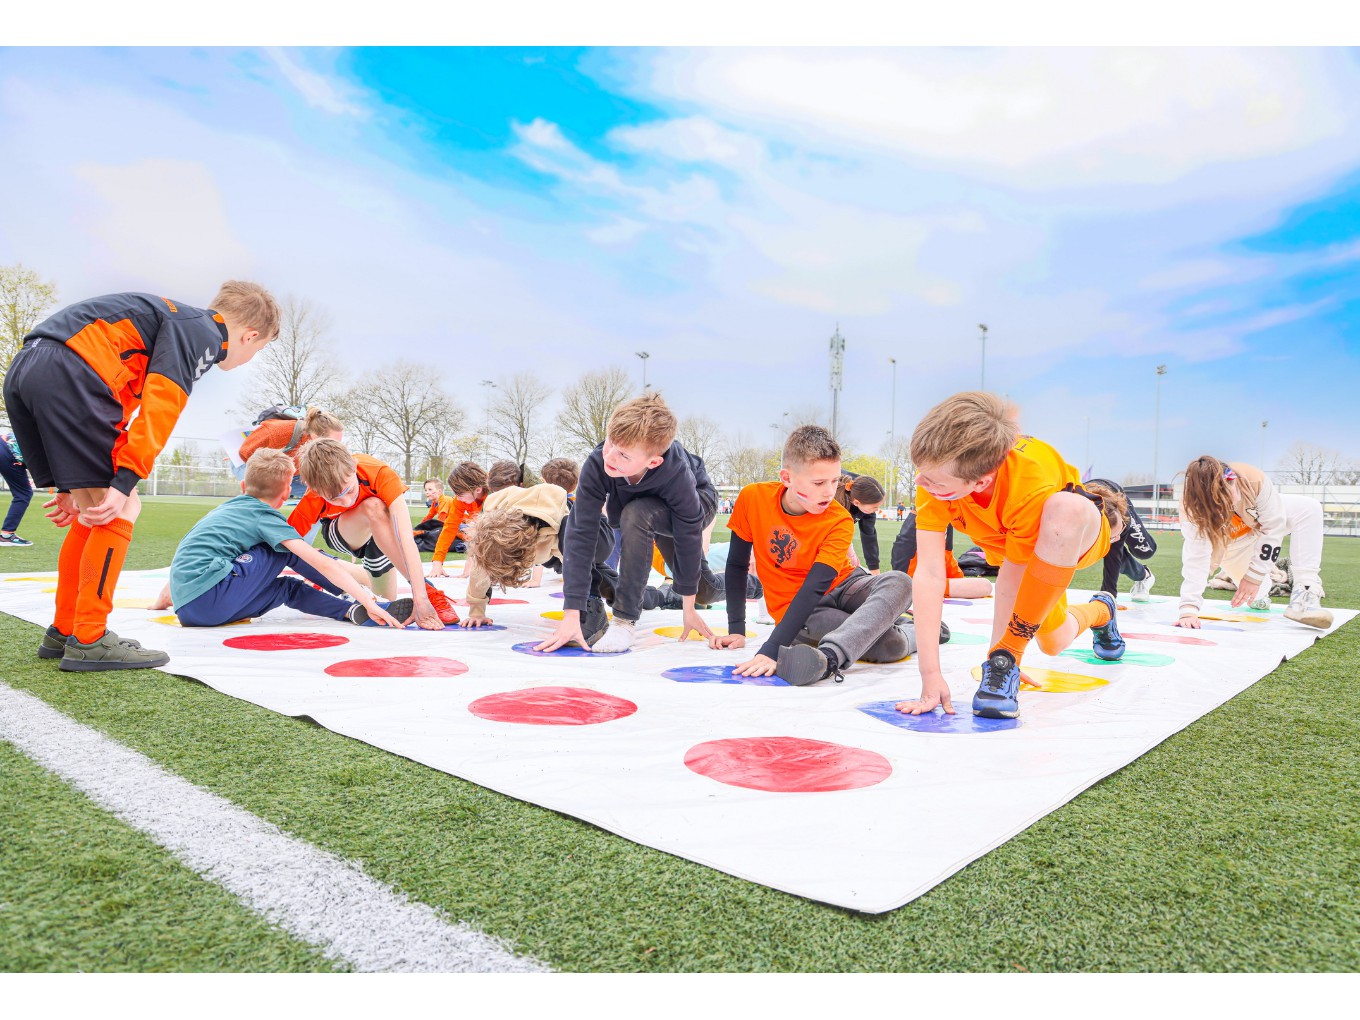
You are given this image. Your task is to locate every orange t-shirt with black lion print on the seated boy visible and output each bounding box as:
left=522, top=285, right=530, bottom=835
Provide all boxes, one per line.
left=728, top=481, right=854, bottom=620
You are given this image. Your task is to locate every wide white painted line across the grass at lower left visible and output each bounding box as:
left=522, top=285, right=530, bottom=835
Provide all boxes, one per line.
left=0, top=681, right=548, bottom=972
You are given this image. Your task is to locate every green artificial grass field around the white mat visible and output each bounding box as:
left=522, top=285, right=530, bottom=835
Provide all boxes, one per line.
left=0, top=500, right=1360, bottom=972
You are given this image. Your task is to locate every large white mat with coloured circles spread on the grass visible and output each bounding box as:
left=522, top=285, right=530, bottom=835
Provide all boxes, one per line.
left=0, top=570, right=1356, bottom=913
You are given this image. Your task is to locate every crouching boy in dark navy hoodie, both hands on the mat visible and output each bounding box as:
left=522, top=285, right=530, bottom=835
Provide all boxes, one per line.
left=537, top=393, right=723, bottom=653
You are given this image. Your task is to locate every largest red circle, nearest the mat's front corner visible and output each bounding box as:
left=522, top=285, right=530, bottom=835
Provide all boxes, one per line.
left=684, top=737, right=892, bottom=793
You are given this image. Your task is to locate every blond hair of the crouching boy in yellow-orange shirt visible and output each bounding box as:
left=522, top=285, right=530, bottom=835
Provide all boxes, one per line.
left=911, top=390, right=1020, bottom=481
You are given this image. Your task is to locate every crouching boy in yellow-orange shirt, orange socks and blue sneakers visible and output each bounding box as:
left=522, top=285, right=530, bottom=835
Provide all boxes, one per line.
left=898, top=392, right=1123, bottom=718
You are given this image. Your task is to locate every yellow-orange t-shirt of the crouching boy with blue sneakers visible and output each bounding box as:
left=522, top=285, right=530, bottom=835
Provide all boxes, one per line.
left=917, top=435, right=1110, bottom=570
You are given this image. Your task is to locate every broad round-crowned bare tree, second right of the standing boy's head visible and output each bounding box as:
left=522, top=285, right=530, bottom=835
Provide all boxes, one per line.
left=340, top=362, right=464, bottom=481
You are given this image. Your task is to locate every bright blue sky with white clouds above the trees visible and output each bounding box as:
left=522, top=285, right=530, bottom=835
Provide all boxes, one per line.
left=0, top=48, right=1360, bottom=479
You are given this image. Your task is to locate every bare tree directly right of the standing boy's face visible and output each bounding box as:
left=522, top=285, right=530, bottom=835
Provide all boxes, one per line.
left=237, top=294, right=344, bottom=420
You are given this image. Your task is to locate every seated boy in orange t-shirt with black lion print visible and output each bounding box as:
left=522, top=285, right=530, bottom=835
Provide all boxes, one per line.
left=709, top=426, right=913, bottom=687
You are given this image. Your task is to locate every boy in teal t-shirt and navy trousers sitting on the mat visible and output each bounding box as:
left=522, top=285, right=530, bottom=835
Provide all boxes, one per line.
left=170, top=449, right=412, bottom=627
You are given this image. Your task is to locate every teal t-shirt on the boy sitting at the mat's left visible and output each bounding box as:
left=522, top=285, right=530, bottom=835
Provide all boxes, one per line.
left=170, top=496, right=299, bottom=605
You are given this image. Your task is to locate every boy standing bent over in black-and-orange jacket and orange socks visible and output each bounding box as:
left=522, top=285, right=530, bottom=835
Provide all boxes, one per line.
left=4, top=280, right=279, bottom=670
